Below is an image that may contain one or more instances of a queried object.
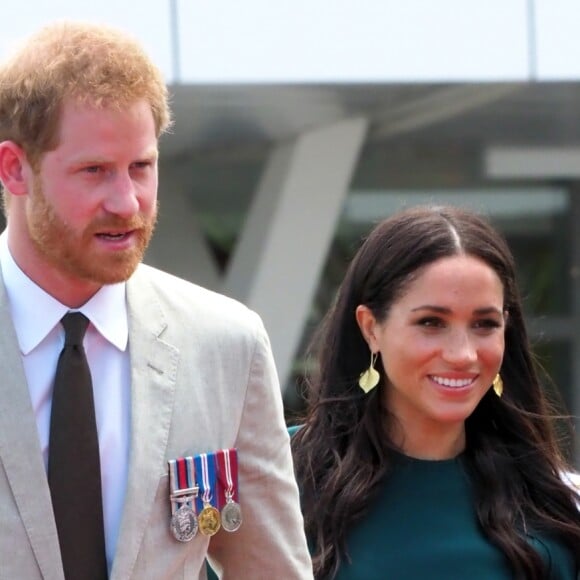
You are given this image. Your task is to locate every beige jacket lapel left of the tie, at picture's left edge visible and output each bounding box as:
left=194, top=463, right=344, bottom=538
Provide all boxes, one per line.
left=0, top=273, right=63, bottom=579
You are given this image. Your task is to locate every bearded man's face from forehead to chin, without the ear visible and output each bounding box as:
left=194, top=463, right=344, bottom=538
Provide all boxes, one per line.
left=18, top=101, right=158, bottom=291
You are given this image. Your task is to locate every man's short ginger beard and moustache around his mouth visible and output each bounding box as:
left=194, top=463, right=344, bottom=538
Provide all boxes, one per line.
left=27, top=176, right=157, bottom=284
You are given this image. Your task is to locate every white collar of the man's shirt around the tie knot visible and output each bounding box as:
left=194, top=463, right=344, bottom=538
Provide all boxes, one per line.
left=0, top=231, right=129, bottom=355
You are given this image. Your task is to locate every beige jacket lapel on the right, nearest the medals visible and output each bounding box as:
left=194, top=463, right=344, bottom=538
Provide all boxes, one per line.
left=111, top=268, right=179, bottom=580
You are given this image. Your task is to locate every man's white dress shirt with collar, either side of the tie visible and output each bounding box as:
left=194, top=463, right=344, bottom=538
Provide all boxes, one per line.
left=0, top=232, right=131, bottom=573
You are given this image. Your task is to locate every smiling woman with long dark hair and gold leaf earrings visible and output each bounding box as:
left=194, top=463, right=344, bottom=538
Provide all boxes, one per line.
left=292, top=208, right=580, bottom=580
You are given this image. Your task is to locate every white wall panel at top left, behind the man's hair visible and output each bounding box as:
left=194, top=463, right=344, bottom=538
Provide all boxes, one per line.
left=0, top=0, right=173, bottom=82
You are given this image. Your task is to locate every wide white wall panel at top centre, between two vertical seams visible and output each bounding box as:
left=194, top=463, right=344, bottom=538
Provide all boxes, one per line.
left=177, top=0, right=532, bottom=83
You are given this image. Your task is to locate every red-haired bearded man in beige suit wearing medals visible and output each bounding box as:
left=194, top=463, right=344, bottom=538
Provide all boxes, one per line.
left=0, top=23, right=312, bottom=580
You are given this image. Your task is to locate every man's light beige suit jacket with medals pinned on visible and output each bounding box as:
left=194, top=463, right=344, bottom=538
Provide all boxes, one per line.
left=0, top=265, right=312, bottom=580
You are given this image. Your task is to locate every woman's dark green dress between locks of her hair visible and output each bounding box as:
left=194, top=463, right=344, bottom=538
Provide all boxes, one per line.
left=290, top=426, right=578, bottom=580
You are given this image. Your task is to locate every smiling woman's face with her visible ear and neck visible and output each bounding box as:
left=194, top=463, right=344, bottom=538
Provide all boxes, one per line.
left=357, top=255, right=506, bottom=457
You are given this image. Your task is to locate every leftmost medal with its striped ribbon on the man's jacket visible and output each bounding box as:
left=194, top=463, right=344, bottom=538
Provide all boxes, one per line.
left=169, top=457, right=199, bottom=542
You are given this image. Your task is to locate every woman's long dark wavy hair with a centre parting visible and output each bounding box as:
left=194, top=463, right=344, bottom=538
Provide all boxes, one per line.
left=292, top=207, right=580, bottom=580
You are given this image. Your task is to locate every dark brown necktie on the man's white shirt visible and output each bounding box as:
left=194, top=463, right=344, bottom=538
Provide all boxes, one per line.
left=48, top=312, right=107, bottom=580
